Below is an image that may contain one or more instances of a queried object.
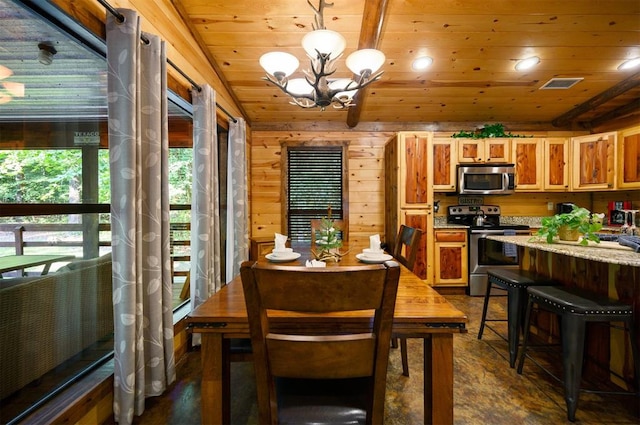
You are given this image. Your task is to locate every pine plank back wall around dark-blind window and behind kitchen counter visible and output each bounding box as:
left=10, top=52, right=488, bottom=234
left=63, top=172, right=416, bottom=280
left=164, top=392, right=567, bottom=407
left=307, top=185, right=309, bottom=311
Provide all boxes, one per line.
left=249, top=131, right=640, bottom=244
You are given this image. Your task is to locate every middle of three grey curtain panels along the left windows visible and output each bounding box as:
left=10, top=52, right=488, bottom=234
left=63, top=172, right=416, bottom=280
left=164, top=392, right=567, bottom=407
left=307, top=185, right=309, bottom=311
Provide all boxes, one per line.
left=191, top=85, right=221, bottom=322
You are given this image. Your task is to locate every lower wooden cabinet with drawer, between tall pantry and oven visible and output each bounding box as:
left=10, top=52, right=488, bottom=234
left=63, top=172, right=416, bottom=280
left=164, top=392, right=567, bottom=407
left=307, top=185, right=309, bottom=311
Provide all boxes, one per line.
left=433, top=230, right=469, bottom=287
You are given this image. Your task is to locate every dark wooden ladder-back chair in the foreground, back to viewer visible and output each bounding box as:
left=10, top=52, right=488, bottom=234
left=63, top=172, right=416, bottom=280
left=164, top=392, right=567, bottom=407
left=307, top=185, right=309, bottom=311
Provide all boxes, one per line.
left=240, top=261, right=400, bottom=424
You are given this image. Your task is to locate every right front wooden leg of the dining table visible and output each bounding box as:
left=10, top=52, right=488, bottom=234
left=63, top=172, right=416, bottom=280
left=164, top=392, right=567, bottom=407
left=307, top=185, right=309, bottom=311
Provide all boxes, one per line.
left=424, top=333, right=453, bottom=425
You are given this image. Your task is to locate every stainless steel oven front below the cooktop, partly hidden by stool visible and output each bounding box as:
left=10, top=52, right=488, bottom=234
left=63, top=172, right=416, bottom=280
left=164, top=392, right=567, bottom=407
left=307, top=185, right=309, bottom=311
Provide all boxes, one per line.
left=469, top=229, right=529, bottom=296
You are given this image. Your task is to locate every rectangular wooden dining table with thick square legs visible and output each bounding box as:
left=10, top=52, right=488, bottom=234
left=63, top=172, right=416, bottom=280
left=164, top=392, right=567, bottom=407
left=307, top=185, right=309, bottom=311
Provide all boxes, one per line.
left=187, top=245, right=467, bottom=424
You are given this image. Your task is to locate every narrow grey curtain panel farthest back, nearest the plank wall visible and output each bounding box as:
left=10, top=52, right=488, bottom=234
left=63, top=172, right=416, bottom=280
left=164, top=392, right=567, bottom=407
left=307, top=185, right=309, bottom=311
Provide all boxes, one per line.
left=226, top=118, right=249, bottom=283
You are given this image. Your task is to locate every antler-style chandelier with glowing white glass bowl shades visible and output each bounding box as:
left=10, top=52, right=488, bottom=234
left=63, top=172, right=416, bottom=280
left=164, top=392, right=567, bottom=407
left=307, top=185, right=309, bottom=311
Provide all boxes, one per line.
left=260, top=0, right=385, bottom=111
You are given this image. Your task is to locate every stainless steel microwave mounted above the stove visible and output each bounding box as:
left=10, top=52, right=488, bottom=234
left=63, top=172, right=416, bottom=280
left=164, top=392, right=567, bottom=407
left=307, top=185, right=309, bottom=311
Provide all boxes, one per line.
left=458, top=164, right=516, bottom=195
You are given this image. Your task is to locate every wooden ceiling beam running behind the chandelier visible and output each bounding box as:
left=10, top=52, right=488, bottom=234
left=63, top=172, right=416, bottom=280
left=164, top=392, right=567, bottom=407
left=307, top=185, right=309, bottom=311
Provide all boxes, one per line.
left=347, top=0, right=387, bottom=128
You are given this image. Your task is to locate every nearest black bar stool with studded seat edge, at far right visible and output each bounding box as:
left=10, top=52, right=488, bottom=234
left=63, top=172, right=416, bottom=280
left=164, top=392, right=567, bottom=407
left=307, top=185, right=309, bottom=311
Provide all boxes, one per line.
left=518, top=286, right=640, bottom=422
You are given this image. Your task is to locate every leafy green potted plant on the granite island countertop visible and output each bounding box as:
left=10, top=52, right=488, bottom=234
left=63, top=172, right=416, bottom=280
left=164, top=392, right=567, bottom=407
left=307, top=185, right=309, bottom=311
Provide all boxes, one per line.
left=536, top=205, right=604, bottom=245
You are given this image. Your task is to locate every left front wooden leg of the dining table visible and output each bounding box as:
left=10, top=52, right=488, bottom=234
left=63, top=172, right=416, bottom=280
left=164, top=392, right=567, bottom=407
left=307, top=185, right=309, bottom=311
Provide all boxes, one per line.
left=200, top=333, right=224, bottom=425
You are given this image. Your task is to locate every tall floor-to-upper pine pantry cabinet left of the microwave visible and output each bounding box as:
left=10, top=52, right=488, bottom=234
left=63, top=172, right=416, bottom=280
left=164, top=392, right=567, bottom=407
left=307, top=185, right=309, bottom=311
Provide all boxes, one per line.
left=385, top=132, right=433, bottom=283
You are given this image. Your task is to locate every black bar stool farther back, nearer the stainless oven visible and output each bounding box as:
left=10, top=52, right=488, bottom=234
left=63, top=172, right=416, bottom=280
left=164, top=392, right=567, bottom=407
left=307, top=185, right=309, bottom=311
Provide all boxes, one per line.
left=478, top=269, right=557, bottom=367
